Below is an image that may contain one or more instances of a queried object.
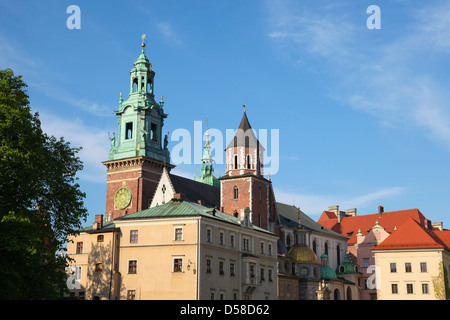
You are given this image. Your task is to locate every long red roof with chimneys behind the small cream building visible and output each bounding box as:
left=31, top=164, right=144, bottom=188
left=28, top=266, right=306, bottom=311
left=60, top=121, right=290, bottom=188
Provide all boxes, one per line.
left=318, top=209, right=427, bottom=244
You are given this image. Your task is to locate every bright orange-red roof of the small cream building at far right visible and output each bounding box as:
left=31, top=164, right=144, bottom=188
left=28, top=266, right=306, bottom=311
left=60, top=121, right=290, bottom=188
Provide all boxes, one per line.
left=372, top=218, right=449, bottom=250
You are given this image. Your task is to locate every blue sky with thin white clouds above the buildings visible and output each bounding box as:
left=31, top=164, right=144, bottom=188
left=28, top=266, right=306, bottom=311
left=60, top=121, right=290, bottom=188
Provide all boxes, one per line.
left=0, top=0, right=450, bottom=227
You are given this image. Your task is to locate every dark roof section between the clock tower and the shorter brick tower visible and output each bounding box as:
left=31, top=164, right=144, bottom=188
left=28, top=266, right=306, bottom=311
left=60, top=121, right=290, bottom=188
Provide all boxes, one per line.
left=169, top=173, right=220, bottom=207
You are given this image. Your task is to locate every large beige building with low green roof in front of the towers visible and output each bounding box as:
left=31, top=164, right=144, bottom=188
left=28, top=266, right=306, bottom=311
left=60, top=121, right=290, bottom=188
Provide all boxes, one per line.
left=67, top=200, right=277, bottom=300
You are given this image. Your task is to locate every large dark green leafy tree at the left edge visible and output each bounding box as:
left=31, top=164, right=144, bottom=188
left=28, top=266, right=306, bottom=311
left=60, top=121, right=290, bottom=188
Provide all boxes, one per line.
left=0, top=69, right=87, bottom=299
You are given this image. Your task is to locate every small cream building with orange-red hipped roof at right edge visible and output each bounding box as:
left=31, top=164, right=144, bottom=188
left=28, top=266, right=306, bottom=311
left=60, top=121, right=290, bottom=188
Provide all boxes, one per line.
left=370, top=219, right=450, bottom=300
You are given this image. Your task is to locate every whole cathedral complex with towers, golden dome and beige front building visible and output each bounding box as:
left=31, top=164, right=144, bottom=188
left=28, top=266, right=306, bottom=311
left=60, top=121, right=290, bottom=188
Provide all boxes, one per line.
left=67, top=37, right=360, bottom=300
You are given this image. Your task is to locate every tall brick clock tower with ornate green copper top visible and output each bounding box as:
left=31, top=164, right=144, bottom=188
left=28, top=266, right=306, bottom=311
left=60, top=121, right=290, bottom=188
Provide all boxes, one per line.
left=103, top=35, right=174, bottom=220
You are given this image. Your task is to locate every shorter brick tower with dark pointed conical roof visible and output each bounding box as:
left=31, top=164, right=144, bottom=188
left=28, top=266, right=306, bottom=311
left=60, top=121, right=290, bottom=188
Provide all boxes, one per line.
left=219, top=110, right=279, bottom=232
